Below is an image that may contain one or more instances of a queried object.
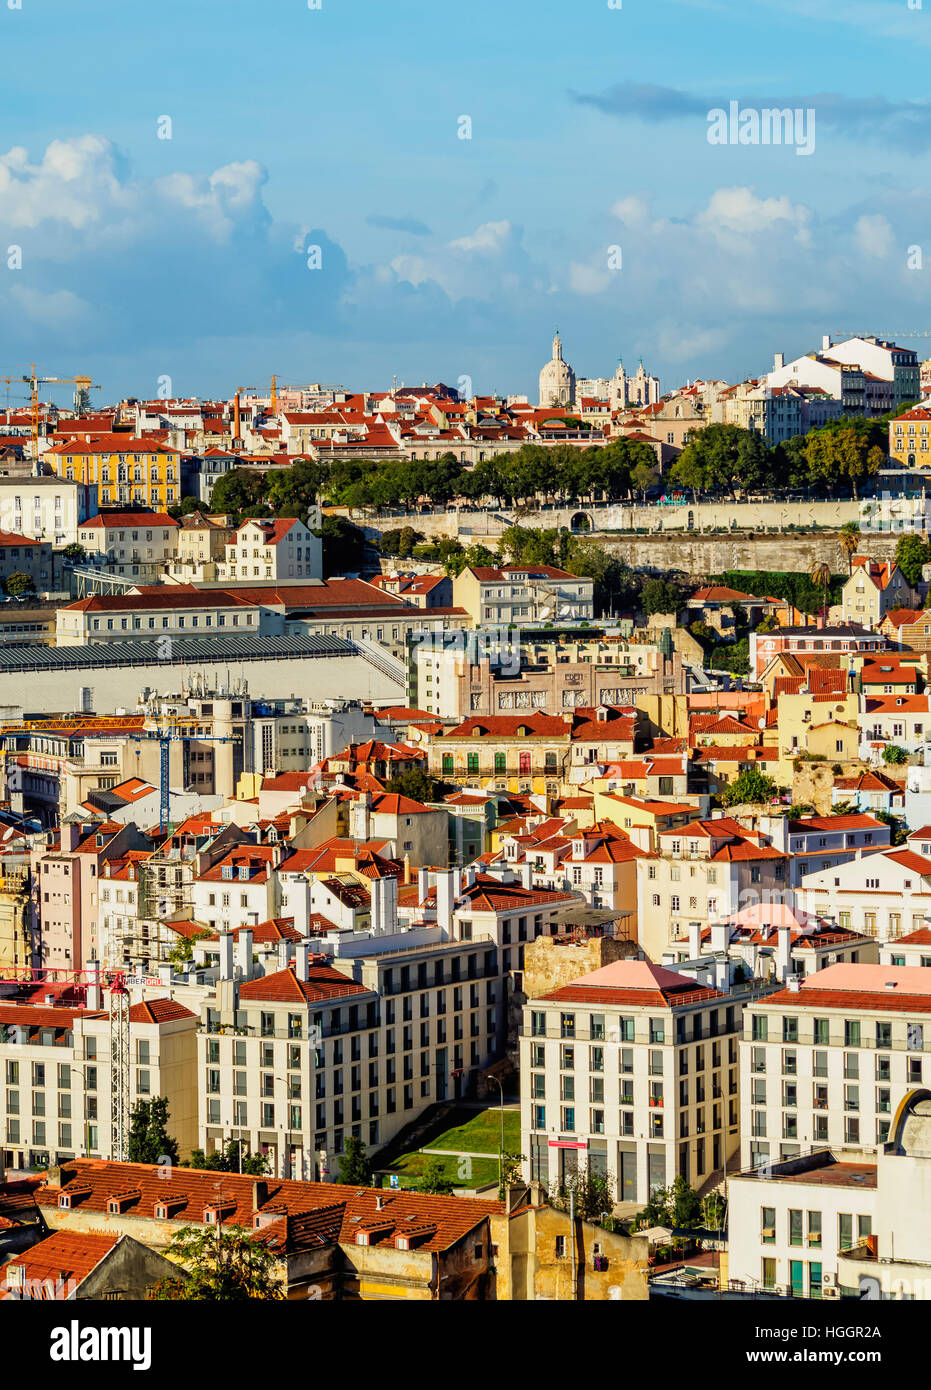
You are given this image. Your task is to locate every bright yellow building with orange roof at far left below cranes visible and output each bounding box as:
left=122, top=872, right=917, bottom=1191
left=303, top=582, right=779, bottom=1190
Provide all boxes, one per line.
left=42, top=434, right=187, bottom=509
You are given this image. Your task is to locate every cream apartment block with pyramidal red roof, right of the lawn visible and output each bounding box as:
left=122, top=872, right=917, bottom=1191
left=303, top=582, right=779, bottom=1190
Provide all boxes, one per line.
left=520, top=960, right=741, bottom=1202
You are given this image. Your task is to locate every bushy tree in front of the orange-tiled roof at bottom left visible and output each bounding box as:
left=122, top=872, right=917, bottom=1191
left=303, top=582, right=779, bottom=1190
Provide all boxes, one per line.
left=153, top=1222, right=285, bottom=1302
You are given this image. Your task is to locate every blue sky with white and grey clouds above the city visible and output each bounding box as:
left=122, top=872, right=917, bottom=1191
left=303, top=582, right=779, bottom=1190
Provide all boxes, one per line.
left=0, top=0, right=931, bottom=399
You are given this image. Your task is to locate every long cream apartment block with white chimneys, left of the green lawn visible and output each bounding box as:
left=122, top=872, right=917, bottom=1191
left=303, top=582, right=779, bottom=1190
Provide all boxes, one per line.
left=199, top=917, right=502, bottom=1180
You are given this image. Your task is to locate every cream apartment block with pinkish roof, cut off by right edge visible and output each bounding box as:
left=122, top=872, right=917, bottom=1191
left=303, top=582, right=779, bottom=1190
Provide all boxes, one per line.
left=741, top=963, right=931, bottom=1168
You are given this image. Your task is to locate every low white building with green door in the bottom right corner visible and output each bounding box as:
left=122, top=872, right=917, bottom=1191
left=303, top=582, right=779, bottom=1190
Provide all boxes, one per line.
left=727, top=1148, right=877, bottom=1298
